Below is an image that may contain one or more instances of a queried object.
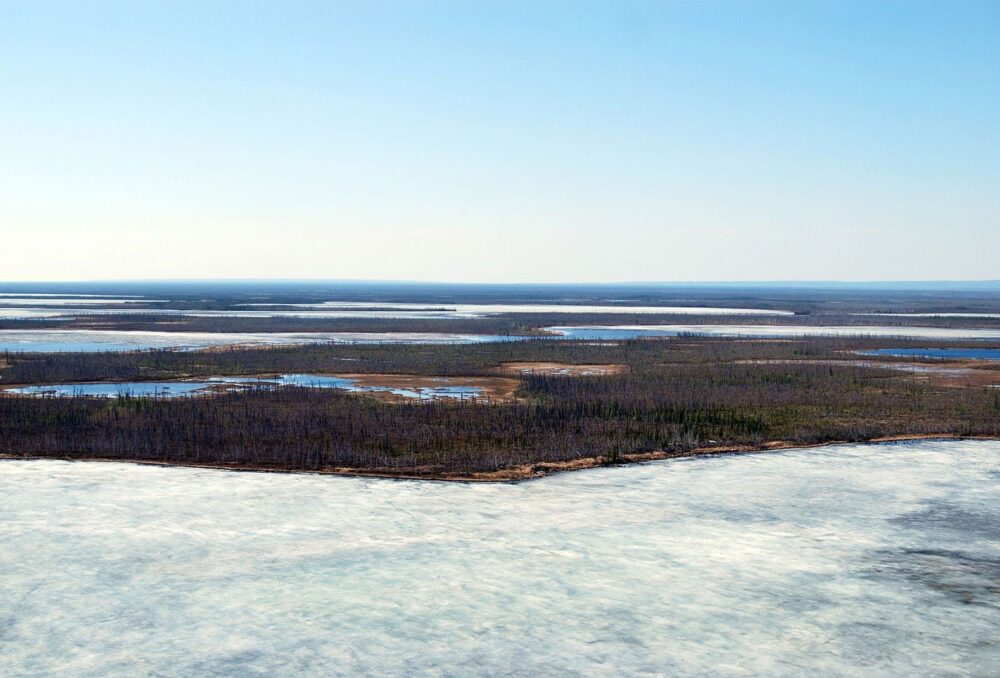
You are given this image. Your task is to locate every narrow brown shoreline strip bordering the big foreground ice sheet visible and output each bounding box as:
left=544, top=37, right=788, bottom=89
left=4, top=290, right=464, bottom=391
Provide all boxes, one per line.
left=0, top=433, right=1000, bottom=483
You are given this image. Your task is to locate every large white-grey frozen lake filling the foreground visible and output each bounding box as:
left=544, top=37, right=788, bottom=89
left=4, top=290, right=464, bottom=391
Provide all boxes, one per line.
left=0, top=441, right=1000, bottom=676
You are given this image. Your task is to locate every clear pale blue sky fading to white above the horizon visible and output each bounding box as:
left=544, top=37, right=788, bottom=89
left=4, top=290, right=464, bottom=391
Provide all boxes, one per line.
left=0, top=0, right=1000, bottom=282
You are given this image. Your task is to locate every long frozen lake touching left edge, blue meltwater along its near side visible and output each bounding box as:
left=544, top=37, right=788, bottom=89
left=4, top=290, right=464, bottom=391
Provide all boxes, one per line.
left=0, top=330, right=520, bottom=353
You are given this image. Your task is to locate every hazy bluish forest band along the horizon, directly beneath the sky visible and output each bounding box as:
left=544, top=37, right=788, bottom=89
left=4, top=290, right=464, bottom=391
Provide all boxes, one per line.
left=0, top=281, right=1000, bottom=314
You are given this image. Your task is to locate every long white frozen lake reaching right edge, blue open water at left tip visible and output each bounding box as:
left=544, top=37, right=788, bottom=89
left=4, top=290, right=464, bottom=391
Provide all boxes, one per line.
left=545, top=325, right=1000, bottom=341
